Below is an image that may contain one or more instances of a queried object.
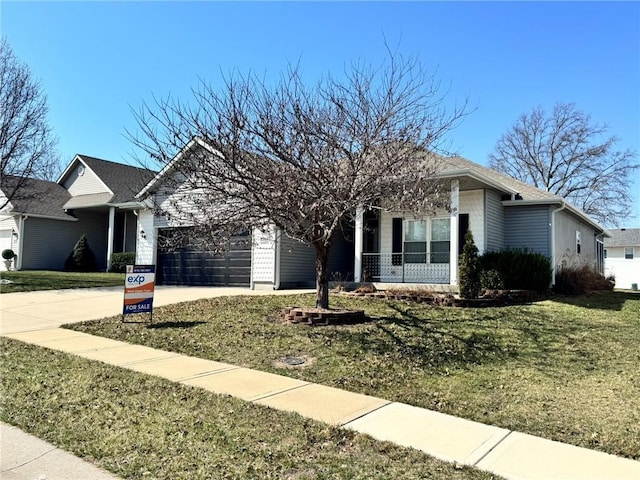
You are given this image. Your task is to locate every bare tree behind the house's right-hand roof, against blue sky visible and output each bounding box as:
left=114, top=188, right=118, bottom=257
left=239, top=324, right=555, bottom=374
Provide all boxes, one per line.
left=489, top=103, right=640, bottom=225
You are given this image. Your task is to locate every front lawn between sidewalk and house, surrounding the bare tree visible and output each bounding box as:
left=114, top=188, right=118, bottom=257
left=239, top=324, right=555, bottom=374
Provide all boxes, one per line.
left=69, top=292, right=640, bottom=459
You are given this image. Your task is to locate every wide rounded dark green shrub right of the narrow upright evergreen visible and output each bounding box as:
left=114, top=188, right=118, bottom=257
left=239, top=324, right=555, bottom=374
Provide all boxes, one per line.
left=479, top=249, right=552, bottom=292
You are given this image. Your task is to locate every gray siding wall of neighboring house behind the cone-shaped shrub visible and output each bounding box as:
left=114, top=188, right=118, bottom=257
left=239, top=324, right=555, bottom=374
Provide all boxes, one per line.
left=22, top=212, right=107, bottom=270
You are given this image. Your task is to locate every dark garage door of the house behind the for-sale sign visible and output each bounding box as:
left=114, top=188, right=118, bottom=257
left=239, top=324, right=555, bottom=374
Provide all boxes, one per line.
left=156, top=231, right=251, bottom=287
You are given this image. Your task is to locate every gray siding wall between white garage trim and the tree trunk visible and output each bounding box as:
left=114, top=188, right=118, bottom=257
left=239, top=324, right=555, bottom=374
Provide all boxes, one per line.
left=280, top=234, right=316, bottom=288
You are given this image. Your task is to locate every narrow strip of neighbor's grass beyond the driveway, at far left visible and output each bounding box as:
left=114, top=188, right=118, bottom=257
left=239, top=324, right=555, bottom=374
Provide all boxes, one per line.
left=0, top=270, right=124, bottom=293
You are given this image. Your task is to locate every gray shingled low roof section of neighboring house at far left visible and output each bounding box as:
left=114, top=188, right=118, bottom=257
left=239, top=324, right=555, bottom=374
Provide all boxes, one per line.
left=2, top=176, right=75, bottom=220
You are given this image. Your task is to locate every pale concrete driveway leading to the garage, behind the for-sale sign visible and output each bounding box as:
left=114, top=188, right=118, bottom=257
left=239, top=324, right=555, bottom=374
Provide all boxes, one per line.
left=0, top=286, right=313, bottom=335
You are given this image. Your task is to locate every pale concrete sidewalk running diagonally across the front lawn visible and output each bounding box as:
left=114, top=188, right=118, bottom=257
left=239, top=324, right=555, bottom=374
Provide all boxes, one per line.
left=0, top=291, right=640, bottom=480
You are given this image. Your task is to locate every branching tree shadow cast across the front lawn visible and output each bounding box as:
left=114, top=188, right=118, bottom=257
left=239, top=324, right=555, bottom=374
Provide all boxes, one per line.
left=322, top=304, right=597, bottom=378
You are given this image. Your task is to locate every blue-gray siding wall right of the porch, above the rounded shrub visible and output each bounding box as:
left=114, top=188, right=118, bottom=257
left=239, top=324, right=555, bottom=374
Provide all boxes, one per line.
left=504, top=205, right=551, bottom=257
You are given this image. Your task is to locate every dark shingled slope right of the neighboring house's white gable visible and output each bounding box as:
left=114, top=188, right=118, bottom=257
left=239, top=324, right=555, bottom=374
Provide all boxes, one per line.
left=77, top=154, right=156, bottom=203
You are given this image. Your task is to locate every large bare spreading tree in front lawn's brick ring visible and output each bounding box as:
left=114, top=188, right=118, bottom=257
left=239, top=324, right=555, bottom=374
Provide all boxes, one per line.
left=128, top=55, right=464, bottom=308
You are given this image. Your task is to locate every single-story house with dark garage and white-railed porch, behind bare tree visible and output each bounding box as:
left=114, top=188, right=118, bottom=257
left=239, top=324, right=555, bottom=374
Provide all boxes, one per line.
left=136, top=139, right=607, bottom=288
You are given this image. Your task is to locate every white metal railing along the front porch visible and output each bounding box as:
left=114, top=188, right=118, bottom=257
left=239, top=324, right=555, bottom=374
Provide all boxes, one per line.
left=361, top=253, right=449, bottom=284
